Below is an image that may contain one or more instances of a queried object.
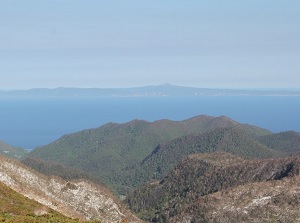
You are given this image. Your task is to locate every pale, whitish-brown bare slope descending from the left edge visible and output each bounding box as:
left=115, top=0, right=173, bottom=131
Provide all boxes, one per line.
left=0, top=156, right=139, bottom=222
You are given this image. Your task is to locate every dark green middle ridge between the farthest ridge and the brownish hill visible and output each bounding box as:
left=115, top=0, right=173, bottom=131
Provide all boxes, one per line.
left=126, top=126, right=285, bottom=187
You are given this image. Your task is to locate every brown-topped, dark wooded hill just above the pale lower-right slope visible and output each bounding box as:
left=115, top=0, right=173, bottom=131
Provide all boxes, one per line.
left=127, top=153, right=300, bottom=222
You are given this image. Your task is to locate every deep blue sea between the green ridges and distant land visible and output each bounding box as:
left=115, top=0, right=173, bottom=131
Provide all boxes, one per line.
left=0, top=96, right=300, bottom=149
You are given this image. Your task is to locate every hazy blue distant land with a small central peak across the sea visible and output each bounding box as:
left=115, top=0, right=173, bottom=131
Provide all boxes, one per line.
left=0, top=84, right=300, bottom=97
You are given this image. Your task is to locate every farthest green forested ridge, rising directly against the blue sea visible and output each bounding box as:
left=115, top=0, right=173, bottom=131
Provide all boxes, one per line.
left=28, top=115, right=271, bottom=193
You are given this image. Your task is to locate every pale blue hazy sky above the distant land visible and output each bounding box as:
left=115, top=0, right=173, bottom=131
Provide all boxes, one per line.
left=0, top=0, right=300, bottom=89
